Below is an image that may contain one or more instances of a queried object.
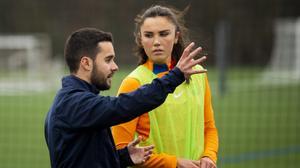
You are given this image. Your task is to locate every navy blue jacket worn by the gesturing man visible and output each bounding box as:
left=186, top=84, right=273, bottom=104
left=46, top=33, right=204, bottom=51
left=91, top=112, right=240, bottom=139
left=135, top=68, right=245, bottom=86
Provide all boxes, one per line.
left=45, top=68, right=184, bottom=168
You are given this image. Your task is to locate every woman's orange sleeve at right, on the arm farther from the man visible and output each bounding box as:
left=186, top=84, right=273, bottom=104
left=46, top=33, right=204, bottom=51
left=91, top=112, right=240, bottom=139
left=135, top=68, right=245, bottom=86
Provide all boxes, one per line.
left=202, top=76, right=219, bottom=163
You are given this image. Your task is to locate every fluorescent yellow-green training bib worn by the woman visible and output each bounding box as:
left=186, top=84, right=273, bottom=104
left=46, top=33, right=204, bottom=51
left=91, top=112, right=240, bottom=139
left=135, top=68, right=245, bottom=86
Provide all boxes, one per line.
left=129, top=65, right=205, bottom=160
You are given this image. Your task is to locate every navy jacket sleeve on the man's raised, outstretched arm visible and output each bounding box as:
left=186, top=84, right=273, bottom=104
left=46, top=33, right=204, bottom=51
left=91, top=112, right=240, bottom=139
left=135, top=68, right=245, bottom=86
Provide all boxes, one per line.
left=57, top=68, right=184, bottom=129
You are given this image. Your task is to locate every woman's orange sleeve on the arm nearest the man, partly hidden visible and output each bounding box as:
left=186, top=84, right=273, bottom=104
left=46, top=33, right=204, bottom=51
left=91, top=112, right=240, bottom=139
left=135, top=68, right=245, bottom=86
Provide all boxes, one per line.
left=112, top=78, right=177, bottom=168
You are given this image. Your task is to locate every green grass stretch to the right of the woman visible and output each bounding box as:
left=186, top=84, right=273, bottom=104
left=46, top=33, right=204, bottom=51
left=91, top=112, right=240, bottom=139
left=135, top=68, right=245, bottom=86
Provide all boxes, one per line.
left=213, top=68, right=300, bottom=168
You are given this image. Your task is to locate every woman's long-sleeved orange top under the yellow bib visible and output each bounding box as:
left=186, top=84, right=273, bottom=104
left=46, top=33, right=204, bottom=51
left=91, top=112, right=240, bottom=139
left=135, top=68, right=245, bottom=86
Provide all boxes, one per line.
left=112, top=60, right=219, bottom=168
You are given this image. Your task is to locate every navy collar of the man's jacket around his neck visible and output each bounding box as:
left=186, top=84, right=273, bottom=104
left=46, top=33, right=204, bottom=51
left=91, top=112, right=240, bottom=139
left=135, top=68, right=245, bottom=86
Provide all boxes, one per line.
left=62, top=75, right=100, bottom=94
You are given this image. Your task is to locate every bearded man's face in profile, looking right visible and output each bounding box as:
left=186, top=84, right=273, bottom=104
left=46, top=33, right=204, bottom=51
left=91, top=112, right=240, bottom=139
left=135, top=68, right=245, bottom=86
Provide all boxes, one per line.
left=91, top=42, right=118, bottom=90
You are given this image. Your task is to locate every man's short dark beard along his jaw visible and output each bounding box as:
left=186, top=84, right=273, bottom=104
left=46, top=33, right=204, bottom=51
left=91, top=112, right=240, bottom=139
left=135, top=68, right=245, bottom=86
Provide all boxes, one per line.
left=91, top=63, right=110, bottom=90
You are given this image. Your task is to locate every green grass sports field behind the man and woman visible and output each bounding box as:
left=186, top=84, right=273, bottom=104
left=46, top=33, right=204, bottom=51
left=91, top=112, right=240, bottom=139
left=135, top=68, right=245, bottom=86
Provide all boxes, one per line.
left=0, top=67, right=300, bottom=168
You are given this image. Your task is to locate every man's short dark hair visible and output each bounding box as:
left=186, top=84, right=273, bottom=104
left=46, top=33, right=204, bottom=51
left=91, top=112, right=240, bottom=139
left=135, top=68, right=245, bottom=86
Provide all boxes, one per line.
left=65, top=28, right=113, bottom=73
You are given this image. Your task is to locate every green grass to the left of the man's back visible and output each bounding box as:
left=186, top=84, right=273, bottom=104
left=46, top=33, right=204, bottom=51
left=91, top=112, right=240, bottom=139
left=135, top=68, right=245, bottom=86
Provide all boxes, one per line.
left=0, top=92, right=54, bottom=168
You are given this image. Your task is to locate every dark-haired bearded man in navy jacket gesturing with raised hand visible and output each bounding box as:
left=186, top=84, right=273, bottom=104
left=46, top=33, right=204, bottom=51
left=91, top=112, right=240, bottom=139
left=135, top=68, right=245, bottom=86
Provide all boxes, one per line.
left=45, top=28, right=205, bottom=168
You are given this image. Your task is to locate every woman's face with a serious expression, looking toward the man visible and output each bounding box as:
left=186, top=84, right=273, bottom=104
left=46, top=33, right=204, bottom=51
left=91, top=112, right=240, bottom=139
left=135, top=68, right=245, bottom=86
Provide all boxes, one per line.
left=140, top=16, right=179, bottom=64
